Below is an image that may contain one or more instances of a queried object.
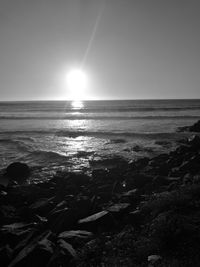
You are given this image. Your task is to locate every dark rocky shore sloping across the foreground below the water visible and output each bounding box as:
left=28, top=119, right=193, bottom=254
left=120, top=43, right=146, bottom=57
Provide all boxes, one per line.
left=0, top=122, right=200, bottom=267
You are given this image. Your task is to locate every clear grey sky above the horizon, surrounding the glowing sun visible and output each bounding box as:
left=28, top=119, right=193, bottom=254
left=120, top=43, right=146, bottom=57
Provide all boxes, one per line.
left=0, top=0, right=200, bottom=100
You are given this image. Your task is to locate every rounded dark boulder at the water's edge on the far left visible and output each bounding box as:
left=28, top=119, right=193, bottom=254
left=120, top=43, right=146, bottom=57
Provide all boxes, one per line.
left=5, top=162, right=31, bottom=184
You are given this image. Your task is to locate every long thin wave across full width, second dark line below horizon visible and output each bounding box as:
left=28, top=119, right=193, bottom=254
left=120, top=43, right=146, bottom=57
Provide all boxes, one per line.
left=0, top=114, right=200, bottom=120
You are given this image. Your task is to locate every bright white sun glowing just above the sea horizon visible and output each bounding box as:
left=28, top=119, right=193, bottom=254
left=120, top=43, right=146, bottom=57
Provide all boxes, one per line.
left=67, top=69, right=88, bottom=100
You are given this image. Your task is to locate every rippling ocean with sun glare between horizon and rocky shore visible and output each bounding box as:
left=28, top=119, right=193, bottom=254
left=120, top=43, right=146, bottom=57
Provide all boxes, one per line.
left=0, top=100, right=200, bottom=180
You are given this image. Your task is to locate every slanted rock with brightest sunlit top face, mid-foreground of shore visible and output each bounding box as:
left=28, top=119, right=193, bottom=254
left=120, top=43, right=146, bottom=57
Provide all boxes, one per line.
left=78, top=210, right=114, bottom=232
